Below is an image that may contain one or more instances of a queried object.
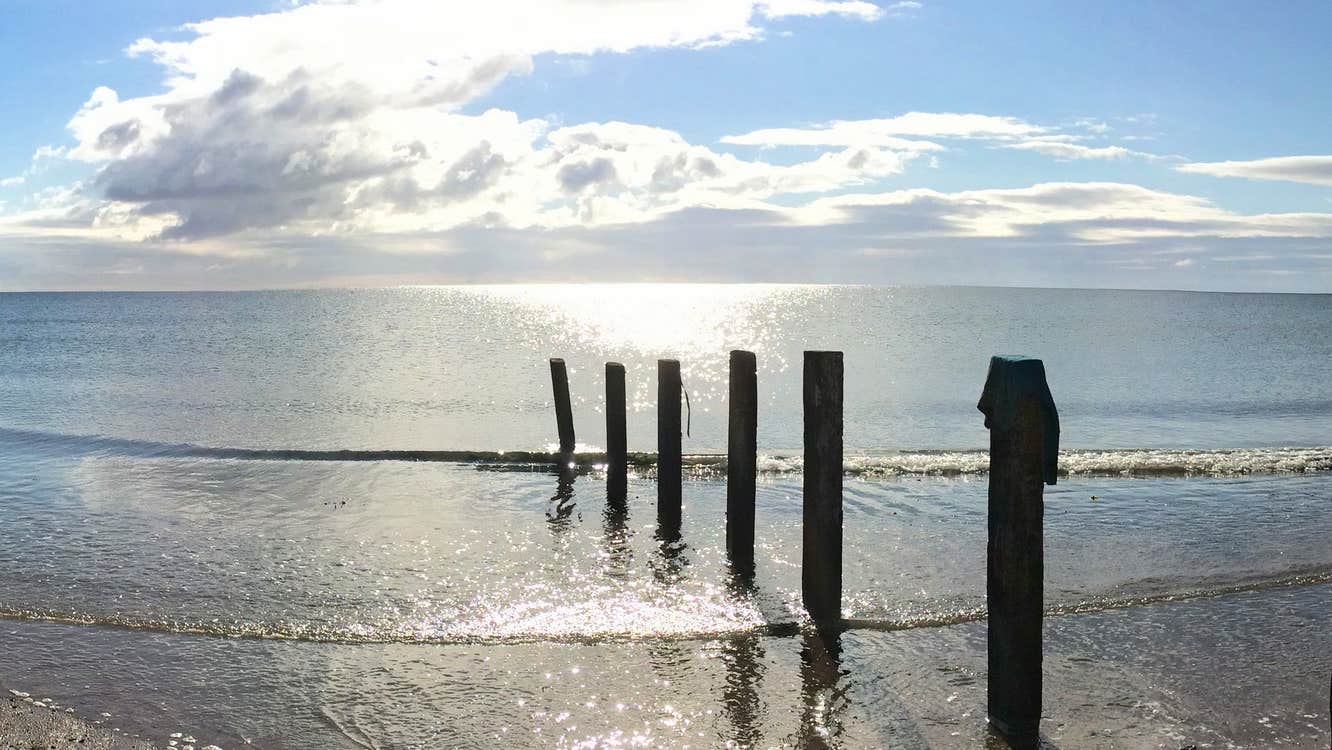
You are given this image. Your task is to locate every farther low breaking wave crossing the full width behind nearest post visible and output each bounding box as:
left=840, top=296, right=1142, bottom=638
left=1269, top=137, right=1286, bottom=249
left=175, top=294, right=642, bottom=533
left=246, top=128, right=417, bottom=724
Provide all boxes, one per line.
left=0, top=428, right=1332, bottom=478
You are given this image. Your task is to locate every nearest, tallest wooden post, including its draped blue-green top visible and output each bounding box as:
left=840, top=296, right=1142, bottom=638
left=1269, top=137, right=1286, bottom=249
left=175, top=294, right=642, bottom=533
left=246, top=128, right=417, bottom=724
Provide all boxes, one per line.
left=978, top=357, right=1059, bottom=747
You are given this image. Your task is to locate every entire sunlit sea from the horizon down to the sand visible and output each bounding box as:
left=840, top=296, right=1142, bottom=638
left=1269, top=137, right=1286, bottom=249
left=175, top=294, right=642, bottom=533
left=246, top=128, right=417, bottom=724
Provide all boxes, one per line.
left=0, top=284, right=1332, bottom=750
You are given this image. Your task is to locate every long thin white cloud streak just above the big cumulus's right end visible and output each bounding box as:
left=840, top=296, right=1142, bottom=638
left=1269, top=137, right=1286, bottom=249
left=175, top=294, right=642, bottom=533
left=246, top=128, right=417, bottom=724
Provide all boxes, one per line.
left=721, top=112, right=1044, bottom=151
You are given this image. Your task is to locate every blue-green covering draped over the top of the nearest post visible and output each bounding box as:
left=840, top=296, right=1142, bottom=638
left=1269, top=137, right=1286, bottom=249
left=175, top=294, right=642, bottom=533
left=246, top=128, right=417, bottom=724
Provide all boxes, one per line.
left=976, top=354, right=1059, bottom=485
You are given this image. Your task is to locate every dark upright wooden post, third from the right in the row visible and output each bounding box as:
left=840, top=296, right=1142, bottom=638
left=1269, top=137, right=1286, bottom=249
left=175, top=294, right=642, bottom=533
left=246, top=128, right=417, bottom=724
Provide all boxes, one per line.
left=726, top=350, right=758, bottom=573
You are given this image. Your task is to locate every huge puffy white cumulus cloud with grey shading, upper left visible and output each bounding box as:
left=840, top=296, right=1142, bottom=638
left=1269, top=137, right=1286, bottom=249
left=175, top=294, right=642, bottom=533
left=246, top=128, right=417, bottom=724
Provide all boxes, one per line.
left=33, top=0, right=914, bottom=240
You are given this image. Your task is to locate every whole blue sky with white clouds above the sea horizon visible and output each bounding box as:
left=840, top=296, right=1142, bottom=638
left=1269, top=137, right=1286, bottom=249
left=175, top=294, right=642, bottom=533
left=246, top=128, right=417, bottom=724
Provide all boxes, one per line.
left=0, top=0, right=1332, bottom=293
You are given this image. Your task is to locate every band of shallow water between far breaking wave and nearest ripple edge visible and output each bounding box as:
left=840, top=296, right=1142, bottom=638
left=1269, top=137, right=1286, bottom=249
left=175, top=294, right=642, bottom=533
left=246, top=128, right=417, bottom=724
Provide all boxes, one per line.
left=0, top=456, right=1332, bottom=642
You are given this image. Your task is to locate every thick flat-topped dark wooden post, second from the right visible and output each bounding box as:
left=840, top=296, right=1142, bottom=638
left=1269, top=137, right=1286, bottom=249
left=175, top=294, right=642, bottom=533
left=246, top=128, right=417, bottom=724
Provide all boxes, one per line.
left=801, top=352, right=842, bottom=626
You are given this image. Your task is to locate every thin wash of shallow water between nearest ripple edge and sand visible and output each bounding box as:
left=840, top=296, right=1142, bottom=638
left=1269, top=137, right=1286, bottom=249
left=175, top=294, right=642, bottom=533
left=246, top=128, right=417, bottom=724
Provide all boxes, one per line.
left=3, top=572, right=1332, bottom=749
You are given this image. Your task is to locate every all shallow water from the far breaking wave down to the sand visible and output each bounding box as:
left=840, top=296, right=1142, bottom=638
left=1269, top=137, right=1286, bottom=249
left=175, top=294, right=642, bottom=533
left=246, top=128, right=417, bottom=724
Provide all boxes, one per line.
left=0, top=456, right=1332, bottom=747
